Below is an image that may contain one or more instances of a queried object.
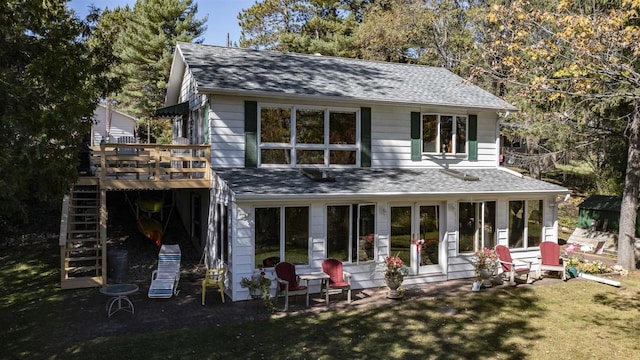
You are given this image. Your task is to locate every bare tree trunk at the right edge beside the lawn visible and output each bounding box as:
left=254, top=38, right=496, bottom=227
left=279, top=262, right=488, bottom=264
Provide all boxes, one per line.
left=618, top=98, right=640, bottom=270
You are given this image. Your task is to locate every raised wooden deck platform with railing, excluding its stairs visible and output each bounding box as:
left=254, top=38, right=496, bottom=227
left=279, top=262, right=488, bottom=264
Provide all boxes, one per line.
left=89, top=144, right=211, bottom=190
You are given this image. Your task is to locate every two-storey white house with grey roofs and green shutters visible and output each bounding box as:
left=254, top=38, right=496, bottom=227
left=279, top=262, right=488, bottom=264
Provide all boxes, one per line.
left=158, top=43, right=569, bottom=301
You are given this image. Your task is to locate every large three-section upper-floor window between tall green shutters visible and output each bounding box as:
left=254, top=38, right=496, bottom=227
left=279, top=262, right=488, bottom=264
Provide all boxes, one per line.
left=258, top=106, right=359, bottom=167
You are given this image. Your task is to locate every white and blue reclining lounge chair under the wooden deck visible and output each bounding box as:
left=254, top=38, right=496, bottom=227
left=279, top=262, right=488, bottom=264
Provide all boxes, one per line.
left=148, top=245, right=181, bottom=299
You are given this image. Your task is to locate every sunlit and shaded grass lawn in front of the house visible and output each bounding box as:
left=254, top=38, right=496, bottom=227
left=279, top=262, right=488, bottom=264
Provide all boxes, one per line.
left=0, top=240, right=640, bottom=359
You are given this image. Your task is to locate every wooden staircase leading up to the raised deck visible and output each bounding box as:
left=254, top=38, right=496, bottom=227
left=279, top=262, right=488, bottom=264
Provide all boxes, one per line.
left=60, top=179, right=106, bottom=289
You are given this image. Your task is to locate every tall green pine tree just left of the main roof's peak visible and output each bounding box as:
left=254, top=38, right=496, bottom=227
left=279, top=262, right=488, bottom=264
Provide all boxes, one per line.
left=114, top=0, right=206, bottom=126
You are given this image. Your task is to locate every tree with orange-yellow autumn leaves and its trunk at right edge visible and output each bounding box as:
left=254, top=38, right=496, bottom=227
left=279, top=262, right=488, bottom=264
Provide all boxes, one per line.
left=487, top=0, right=640, bottom=269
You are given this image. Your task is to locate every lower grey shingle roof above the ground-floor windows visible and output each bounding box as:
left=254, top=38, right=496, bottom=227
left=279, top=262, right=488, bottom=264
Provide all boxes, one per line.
left=214, top=168, right=568, bottom=200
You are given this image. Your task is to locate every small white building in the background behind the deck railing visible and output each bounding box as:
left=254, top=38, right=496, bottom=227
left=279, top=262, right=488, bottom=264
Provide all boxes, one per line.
left=90, top=102, right=138, bottom=146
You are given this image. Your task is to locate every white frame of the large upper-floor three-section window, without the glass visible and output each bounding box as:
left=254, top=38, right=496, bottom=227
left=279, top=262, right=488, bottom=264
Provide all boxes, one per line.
left=258, top=103, right=361, bottom=168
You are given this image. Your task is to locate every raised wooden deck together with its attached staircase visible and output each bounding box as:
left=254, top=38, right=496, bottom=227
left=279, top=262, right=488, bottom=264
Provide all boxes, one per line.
left=60, top=143, right=211, bottom=289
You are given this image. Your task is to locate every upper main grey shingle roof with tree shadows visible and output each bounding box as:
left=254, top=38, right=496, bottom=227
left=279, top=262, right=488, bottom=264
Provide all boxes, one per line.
left=177, top=43, right=516, bottom=110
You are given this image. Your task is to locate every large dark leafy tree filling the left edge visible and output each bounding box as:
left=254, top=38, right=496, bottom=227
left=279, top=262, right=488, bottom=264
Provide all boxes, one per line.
left=0, top=0, right=101, bottom=231
